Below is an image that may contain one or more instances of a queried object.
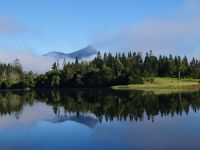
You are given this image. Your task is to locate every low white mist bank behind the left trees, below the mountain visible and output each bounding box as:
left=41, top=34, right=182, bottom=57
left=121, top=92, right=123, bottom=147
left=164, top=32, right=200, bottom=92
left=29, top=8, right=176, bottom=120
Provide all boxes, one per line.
left=0, top=49, right=95, bottom=74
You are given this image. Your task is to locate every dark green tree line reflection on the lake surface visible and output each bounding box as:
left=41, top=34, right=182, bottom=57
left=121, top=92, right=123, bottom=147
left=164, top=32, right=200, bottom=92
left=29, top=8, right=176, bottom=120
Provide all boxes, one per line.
left=0, top=89, right=200, bottom=122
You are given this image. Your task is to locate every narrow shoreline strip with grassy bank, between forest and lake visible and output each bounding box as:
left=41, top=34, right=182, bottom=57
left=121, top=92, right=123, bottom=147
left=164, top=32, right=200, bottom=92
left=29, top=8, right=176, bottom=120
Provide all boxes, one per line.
left=0, top=77, right=200, bottom=94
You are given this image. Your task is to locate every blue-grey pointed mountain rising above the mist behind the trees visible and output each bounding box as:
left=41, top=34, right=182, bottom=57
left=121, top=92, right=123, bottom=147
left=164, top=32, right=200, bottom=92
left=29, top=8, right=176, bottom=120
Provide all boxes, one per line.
left=43, top=45, right=97, bottom=59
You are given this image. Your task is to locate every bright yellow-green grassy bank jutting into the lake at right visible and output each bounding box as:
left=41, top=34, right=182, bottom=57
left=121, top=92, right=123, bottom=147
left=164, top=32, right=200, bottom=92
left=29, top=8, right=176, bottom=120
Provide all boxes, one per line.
left=112, top=77, right=200, bottom=94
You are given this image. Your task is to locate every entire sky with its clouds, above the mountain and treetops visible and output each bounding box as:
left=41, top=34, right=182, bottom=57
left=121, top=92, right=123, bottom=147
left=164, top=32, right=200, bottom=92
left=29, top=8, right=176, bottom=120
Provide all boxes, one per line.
left=0, top=0, right=200, bottom=72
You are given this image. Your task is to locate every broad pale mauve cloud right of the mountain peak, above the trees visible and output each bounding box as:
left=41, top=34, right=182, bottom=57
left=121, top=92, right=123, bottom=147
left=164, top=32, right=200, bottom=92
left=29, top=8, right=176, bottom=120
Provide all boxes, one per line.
left=92, top=0, right=200, bottom=56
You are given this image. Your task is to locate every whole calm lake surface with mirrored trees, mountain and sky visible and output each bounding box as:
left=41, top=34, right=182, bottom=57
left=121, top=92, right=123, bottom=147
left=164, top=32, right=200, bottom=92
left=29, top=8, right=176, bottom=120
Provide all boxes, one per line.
left=0, top=89, right=200, bottom=150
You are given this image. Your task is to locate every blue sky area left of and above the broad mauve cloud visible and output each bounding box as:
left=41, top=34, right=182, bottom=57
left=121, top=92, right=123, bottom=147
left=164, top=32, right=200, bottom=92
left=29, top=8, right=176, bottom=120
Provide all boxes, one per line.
left=0, top=0, right=193, bottom=54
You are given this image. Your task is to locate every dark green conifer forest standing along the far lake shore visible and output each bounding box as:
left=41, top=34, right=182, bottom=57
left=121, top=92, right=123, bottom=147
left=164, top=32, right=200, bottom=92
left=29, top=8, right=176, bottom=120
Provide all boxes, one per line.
left=0, top=51, right=200, bottom=89
